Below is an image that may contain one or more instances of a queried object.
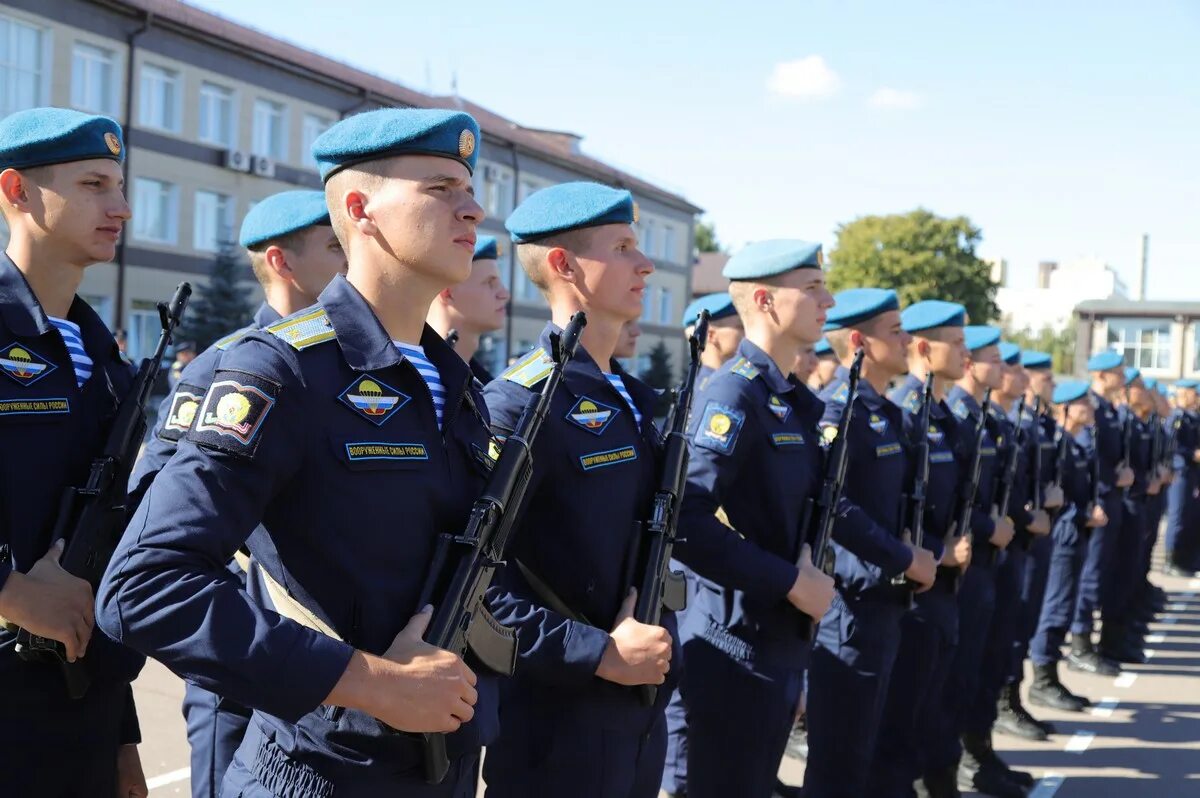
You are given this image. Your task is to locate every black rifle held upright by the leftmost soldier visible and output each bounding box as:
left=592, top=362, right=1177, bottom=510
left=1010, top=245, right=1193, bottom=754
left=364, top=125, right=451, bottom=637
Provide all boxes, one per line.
left=16, top=282, right=192, bottom=698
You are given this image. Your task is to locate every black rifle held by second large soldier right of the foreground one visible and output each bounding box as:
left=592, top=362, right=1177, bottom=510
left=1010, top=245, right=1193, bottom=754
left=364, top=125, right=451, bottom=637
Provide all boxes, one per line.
left=634, top=311, right=708, bottom=707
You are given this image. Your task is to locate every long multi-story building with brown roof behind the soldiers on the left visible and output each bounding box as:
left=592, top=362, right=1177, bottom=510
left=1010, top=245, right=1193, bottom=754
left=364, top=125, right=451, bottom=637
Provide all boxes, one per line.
left=0, top=0, right=700, bottom=372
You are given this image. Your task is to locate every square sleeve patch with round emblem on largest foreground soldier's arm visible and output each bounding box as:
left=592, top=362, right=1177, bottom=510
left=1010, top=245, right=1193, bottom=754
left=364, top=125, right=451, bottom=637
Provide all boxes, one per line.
left=187, top=370, right=280, bottom=458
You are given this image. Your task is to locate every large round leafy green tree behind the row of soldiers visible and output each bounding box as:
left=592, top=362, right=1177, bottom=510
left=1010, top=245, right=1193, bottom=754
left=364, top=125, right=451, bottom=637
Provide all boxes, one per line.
left=829, top=209, right=998, bottom=324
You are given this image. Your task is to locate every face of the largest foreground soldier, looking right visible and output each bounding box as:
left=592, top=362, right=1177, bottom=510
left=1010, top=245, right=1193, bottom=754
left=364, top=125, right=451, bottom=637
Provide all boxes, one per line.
left=366, top=155, right=484, bottom=286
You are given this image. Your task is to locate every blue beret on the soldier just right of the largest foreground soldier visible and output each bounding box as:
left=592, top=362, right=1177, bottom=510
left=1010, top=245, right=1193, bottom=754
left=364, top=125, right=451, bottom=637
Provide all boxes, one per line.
left=504, top=181, right=637, bottom=244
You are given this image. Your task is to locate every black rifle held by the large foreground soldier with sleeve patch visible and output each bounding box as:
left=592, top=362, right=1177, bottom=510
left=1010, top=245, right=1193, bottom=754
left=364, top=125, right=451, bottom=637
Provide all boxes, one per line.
left=418, top=313, right=587, bottom=784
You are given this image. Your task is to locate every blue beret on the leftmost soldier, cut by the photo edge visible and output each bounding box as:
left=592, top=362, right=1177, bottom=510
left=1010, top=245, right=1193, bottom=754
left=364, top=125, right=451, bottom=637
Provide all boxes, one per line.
left=0, top=108, right=125, bottom=169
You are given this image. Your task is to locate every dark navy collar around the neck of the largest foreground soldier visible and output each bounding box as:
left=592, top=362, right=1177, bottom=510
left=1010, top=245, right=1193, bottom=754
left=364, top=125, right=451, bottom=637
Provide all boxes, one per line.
left=317, top=275, right=470, bottom=391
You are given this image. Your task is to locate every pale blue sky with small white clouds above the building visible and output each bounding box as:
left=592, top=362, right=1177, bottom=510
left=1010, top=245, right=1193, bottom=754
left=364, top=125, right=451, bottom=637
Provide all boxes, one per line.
left=191, top=0, right=1200, bottom=299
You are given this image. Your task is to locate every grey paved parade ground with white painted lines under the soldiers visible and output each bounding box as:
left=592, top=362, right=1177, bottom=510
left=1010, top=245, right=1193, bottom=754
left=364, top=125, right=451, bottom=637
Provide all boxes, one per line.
left=133, top=554, right=1200, bottom=798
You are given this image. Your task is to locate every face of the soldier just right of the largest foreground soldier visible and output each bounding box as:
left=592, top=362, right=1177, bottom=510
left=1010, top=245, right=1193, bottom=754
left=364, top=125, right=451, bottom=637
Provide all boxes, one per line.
left=572, top=224, right=654, bottom=322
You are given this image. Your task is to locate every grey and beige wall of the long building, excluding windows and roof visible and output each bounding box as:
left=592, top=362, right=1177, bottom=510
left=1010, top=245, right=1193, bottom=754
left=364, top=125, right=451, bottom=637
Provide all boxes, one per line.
left=0, top=0, right=694, bottom=373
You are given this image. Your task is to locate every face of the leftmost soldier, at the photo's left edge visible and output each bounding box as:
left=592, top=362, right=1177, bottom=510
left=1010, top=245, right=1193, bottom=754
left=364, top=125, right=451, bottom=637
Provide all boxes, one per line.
left=17, top=158, right=131, bottom=266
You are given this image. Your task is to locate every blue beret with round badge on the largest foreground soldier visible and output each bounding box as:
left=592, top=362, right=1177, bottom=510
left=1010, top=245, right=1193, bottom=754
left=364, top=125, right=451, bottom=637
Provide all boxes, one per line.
left=312, top=108, right=479, bottom=180
